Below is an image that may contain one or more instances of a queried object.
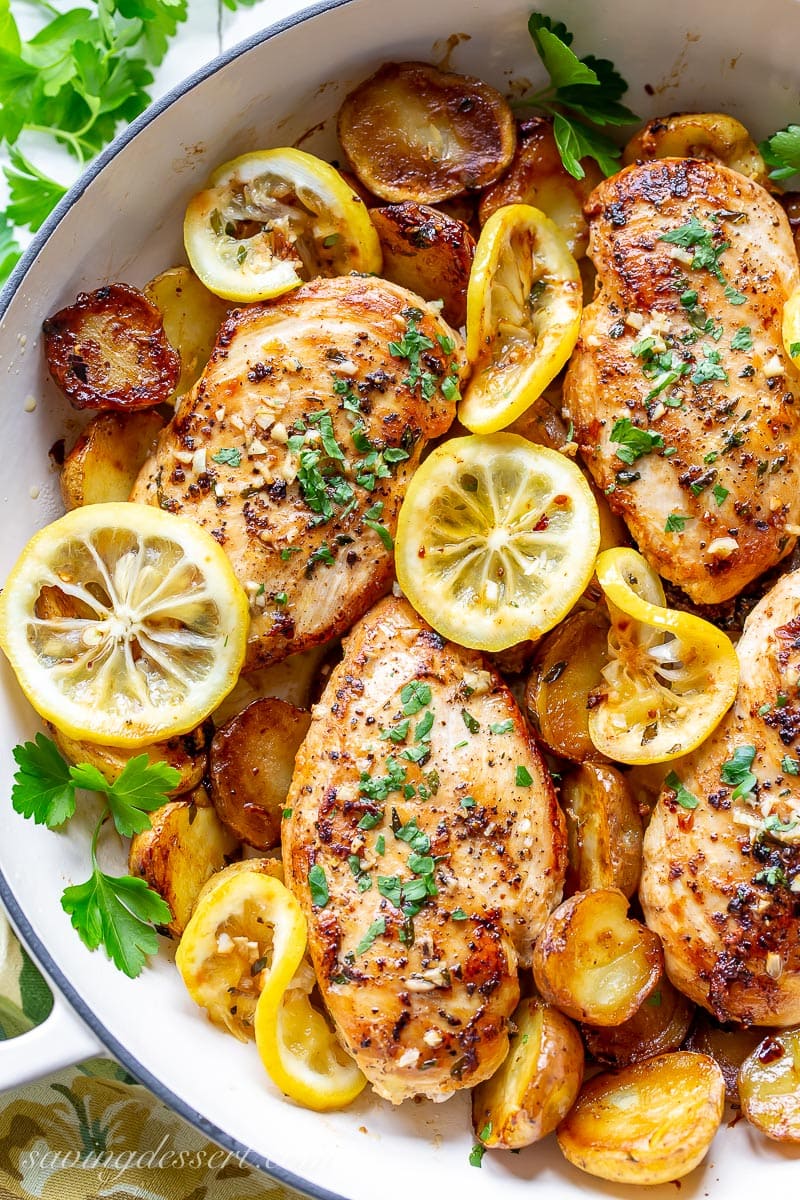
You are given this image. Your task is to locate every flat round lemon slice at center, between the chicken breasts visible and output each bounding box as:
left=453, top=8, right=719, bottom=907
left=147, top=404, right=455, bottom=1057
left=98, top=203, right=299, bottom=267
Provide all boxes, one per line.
left=395, top=433, right=600, bottom=650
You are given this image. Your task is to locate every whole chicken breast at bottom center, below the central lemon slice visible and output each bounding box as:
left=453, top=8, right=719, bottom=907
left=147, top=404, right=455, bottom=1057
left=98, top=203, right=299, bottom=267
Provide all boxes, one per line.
left=283, top=598, right=565, bottom=1104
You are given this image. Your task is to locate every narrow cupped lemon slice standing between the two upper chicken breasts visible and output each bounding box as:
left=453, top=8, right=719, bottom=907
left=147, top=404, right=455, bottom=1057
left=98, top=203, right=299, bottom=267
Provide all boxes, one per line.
left=458, top=204, right=583, bottom=433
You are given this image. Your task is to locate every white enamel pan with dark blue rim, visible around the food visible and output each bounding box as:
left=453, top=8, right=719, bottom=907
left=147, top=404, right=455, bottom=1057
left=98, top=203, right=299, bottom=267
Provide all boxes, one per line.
left=0, top=0, right=800, bottom=1200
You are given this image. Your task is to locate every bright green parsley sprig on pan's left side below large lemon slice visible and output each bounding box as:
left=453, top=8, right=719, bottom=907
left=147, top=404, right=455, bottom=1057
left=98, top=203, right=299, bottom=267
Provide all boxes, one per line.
left=11, top=733, right=180, bottom=978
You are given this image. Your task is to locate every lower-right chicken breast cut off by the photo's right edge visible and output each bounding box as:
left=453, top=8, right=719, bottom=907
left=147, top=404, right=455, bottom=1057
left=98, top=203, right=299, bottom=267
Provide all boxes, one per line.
left=640, top=571, right=800, bottom=1025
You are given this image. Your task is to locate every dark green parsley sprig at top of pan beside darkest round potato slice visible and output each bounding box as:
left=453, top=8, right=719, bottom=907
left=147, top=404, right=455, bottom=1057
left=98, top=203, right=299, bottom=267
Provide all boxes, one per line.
left=518, top=12, right=638, bottom=179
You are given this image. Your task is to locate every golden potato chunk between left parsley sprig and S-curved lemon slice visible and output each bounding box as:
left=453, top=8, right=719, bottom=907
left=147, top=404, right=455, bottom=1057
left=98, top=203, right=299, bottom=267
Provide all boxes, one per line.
left=128, top=788, right=239, bottom=937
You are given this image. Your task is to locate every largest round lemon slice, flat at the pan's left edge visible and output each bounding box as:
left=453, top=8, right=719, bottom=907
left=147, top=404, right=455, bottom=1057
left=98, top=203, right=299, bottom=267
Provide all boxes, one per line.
left=0, top=503, right=248, bottom=748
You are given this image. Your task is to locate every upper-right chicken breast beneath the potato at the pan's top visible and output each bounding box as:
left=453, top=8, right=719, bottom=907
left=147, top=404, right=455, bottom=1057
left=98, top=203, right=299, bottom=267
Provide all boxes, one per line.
left=564, top=158, right=800, bottom=604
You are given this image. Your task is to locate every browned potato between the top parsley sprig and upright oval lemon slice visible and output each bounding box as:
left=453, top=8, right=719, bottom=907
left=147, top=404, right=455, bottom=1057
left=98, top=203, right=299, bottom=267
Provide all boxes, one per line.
left=479, top=116, right=603, bottom=258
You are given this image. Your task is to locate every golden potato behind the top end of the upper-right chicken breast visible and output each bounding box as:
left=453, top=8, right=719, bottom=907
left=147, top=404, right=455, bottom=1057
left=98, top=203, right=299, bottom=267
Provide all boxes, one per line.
left=622, top=113, right=769, bottom=187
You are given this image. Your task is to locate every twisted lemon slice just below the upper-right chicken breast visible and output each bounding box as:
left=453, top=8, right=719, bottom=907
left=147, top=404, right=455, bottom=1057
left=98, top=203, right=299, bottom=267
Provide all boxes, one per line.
left=589, top=550, right=739, bottom=763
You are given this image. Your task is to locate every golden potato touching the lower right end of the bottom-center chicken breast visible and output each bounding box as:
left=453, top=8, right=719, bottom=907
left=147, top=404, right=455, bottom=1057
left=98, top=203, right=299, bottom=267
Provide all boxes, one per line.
left=473, top=996, right=583, bottom=1150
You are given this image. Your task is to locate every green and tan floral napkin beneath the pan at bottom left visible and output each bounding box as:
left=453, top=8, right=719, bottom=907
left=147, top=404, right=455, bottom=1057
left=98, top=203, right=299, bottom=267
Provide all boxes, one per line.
left=0, top=911, right=300, bottom=1200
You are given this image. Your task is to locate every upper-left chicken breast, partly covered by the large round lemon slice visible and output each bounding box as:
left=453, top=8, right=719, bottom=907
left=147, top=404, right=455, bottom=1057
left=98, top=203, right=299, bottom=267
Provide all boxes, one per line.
left=131, top=276, right=464, bottom=671
